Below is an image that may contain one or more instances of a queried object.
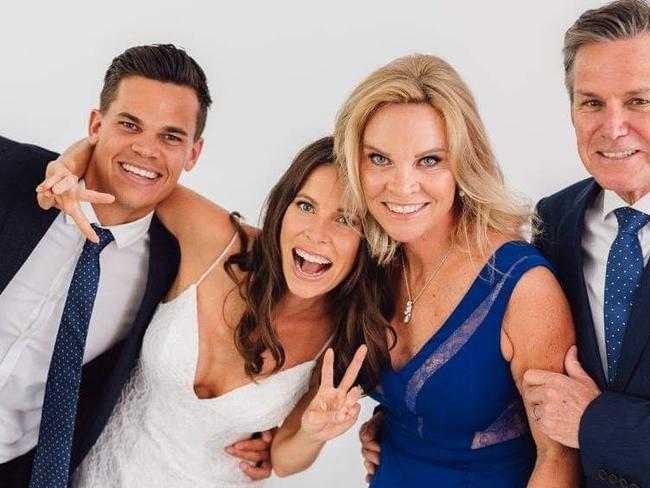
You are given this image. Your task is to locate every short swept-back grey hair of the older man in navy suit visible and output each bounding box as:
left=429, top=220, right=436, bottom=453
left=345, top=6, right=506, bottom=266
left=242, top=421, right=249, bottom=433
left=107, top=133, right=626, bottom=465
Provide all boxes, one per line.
left=562, top=0, right=650, bottom=100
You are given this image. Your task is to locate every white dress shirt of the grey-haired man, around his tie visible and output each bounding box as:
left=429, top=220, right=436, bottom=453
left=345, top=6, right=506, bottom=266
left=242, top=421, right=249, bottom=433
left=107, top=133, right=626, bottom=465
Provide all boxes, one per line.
left=582, top=190, right=650, bottom=377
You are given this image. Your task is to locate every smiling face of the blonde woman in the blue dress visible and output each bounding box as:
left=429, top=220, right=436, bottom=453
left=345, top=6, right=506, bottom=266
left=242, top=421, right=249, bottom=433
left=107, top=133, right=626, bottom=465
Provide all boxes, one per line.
left=359, top=104, right=456, bottom=243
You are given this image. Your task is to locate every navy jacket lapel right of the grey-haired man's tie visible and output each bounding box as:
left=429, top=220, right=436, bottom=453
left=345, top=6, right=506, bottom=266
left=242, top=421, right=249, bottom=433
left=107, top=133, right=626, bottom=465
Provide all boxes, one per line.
left=612, top=252, right=650, bottom=391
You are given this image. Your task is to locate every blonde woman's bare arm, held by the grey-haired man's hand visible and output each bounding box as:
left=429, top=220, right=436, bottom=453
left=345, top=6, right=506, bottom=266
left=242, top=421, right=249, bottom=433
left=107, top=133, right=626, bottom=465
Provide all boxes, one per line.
left=502, top=267, right=579, bottom=488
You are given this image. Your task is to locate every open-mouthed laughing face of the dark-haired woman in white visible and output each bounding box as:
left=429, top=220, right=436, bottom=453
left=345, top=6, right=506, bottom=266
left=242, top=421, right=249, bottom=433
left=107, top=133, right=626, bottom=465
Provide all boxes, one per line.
left=280, top=163, right=361, bottom=298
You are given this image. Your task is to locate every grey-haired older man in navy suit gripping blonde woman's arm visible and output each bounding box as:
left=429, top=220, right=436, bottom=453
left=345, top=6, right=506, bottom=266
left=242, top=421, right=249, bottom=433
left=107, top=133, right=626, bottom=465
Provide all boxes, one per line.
left=524, top=0, right=650, bottom=488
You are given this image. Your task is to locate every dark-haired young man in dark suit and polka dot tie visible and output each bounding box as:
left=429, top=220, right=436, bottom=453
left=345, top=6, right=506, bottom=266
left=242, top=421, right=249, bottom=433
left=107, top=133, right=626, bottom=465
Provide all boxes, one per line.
left=0, top=45, right=268, bottom=488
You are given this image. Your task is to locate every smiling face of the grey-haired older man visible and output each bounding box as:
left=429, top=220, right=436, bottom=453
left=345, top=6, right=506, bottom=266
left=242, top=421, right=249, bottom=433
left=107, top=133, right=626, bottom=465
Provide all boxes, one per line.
left=571, top=35, right=650, bottom=202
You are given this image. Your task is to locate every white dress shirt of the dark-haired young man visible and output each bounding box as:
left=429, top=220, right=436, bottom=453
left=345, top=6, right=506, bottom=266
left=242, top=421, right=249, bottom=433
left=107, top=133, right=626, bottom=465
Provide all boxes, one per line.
left=0, top=202, right=153, bottom=463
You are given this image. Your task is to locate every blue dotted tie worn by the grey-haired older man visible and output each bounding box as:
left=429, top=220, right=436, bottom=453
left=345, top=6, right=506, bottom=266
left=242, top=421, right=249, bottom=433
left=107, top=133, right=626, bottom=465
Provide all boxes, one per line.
left=605, top=207, right=650, bottom=383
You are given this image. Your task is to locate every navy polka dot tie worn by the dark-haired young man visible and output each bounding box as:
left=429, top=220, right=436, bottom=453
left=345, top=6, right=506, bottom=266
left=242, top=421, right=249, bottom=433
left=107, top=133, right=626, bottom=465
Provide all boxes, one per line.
left=29, top=225, right=113, bottom=488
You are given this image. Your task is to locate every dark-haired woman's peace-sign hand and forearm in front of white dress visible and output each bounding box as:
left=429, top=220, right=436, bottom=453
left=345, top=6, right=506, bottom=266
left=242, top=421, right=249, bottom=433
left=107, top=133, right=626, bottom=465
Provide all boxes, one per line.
left=271, top=346, right=366, bottom=477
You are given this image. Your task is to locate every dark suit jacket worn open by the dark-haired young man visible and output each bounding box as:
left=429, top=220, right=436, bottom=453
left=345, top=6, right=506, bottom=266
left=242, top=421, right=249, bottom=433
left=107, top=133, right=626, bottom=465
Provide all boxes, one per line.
left=0, top=137, right=180, bottom=478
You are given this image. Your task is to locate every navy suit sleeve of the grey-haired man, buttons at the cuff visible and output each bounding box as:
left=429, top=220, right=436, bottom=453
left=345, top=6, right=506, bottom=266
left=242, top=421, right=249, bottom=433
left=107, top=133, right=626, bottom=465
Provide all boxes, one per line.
left=579, top=391, right=650, bottom=486
